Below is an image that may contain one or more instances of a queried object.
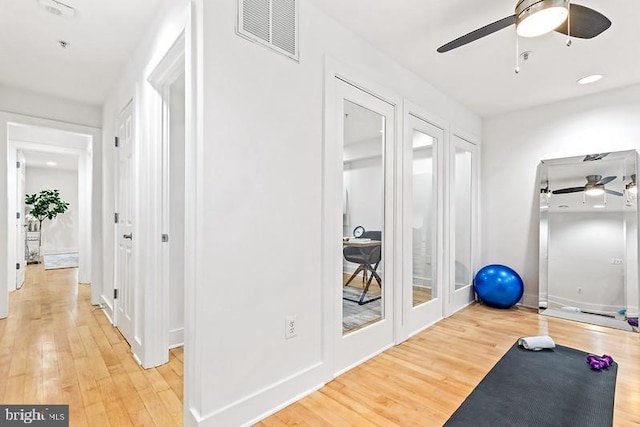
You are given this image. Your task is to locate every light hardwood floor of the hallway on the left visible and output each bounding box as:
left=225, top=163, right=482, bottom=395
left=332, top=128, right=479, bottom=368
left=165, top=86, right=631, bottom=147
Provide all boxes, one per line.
left=0, top=264, right=183, bottom=427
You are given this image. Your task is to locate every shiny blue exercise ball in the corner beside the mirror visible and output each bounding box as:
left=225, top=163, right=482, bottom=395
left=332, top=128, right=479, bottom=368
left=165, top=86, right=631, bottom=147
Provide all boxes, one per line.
left=473, top=264, right=524, bottom=308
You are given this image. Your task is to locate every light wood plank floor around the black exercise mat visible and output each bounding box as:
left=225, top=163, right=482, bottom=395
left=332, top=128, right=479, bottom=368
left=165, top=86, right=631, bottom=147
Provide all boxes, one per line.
left=257, top=305, right=640, bottom=427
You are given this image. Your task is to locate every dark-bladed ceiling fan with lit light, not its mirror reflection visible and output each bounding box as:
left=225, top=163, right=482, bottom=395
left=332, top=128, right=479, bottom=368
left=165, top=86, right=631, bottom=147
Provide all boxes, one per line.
left=437, top=0, right=611, bottom=53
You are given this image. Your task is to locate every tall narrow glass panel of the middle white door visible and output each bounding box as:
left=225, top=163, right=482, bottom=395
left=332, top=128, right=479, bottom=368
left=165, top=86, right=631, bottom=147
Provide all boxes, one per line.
left=411, top=129, right=438, bottom=307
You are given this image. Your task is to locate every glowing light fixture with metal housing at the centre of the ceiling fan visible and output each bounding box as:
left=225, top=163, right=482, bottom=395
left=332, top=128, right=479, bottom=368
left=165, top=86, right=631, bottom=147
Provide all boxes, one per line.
left=516, top=0, right=569, bottom=37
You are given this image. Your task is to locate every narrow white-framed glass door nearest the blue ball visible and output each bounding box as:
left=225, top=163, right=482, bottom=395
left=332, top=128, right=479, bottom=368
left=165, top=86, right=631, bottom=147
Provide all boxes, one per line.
left=447, top=135, right=478, bottom=314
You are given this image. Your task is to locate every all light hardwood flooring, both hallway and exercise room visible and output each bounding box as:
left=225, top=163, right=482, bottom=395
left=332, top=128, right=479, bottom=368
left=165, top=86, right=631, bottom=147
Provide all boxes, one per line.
left=5, top=265, right=640, bottom=427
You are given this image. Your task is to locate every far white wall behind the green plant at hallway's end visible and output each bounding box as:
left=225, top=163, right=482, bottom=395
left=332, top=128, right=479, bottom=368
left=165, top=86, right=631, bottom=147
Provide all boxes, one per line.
left=25, top=166, right=80, bottom=255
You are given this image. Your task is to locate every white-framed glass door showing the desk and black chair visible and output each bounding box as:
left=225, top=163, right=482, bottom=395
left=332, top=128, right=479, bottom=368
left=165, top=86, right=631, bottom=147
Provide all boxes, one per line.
left=328, top=78, right=396, bottom=374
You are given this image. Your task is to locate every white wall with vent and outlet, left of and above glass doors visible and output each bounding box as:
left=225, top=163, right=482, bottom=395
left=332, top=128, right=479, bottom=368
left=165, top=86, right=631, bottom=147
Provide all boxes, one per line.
left=192, top=0, right=481, bottom=425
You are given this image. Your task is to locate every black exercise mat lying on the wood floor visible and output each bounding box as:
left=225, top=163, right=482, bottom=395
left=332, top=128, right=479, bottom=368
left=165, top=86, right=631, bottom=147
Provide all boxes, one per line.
left=445, top=343, right=618, bottom=427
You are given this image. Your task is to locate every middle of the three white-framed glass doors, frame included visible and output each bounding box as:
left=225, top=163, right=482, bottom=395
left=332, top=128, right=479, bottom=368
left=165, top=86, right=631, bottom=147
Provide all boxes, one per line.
left=402, top=114, right=444, bottom=335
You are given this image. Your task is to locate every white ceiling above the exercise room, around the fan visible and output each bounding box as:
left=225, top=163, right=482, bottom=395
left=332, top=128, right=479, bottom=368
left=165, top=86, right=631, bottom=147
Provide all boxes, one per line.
left=311, top=0, right=640, bottom=117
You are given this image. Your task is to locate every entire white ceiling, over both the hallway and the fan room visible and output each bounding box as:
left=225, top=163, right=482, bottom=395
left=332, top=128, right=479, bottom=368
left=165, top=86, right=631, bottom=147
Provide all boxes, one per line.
left=0, top=0, right=640, bottom=117
